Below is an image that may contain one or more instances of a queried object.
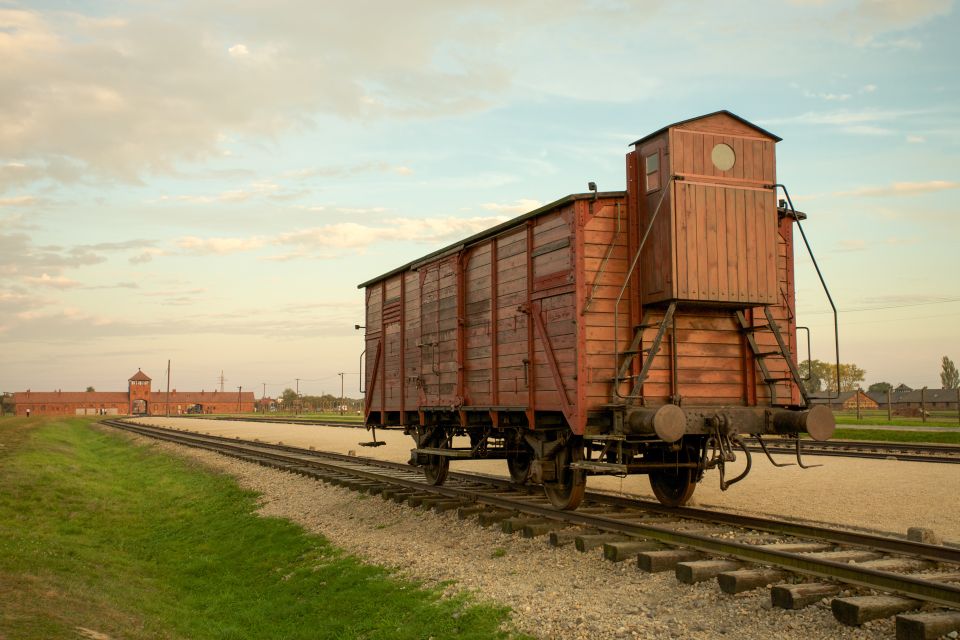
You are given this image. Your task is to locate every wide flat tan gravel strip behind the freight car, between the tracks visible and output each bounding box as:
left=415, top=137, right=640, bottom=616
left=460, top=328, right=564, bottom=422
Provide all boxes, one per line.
left=144, top=418, right=960, bottom=543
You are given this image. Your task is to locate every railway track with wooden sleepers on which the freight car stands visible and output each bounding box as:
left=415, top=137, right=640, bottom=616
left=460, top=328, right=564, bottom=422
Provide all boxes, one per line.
left=104, top=420, right=960, bottom=638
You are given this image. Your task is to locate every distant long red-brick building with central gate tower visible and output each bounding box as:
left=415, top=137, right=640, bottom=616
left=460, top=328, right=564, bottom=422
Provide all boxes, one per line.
left=13, top=370, right=256, bottom=416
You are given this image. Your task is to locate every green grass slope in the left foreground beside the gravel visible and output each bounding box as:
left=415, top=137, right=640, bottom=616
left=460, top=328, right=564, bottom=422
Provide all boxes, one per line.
left=0, top=418, right=520, bottom=640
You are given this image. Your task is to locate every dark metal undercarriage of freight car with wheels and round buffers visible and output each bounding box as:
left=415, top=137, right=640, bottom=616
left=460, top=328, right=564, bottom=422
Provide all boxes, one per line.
left=398, top=405, right=835, bottom=509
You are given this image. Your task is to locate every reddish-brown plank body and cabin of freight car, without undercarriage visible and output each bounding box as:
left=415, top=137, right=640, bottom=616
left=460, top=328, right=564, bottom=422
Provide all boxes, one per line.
left=364, top=114, right=800, bottom=433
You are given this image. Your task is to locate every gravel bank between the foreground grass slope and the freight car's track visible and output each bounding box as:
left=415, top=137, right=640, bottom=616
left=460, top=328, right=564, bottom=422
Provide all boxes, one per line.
left=116, top=420, right=932, bottom=640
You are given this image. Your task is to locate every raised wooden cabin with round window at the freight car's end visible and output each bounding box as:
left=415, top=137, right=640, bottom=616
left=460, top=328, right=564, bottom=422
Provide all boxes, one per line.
left=635, top=114, right=778, bottom=307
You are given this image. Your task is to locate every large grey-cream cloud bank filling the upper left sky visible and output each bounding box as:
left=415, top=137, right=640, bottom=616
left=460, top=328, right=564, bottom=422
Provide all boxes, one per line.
left=0, top=0, right=516, bottom=188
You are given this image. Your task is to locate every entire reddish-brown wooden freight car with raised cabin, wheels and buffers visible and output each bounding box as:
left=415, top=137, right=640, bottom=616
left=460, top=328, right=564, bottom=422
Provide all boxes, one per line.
left=359, top=111, right=834, bottom=509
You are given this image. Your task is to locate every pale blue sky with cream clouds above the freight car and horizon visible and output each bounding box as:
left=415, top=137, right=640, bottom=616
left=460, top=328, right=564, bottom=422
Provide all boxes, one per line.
left=0, top=0, right=960, bottom=396
